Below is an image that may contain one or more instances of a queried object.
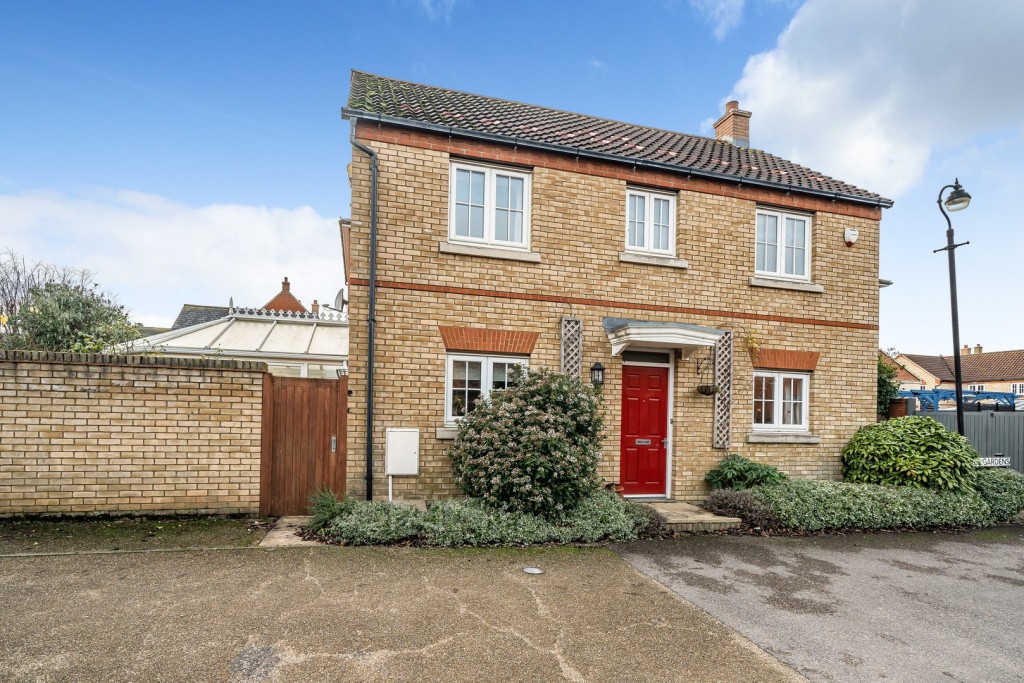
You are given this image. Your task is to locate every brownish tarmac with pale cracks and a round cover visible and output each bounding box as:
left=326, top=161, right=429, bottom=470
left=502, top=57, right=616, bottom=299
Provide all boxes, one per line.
left=0, top=548, right=802, bottom=683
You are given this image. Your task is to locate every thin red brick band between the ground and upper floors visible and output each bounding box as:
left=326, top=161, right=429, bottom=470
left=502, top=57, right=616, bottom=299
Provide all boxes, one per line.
left=349, top=278, right=879, bottom=331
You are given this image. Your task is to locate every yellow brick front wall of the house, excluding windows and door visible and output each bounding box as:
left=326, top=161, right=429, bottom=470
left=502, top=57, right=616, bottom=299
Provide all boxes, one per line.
left=348, top=129, right=879, bottom=501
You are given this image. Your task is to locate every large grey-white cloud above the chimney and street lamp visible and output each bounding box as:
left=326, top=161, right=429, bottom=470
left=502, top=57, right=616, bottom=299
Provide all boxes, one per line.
left=723, top=0, right=1024, bottom=198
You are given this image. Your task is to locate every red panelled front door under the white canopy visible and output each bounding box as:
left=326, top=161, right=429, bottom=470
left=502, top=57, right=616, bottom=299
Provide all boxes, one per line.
left=618, top=366, right=669, bottom=496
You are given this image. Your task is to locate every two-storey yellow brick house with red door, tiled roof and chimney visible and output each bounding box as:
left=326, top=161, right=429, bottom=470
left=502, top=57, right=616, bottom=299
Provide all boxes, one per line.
left=343, top=72, right=892, bottom=500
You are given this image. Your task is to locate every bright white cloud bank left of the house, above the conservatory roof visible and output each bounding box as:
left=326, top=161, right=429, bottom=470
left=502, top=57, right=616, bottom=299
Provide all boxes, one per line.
left=0, top=190, right=344, bottom=326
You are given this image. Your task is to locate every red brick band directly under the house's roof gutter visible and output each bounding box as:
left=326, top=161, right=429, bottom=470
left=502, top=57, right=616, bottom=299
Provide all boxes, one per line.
left=356, top=121, right=882, bottom=220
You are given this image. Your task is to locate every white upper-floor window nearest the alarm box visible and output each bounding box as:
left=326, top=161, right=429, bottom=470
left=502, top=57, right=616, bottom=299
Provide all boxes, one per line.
left=754, top=209, right=811, bottom=281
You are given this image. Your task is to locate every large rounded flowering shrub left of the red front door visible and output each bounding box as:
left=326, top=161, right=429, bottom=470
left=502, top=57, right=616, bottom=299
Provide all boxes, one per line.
left=449, top=367, right=603, bottom=518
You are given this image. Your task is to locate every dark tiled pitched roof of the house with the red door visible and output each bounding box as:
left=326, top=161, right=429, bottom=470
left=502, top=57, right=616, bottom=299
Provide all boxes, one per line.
left=343, top=70, right=892, bottom=207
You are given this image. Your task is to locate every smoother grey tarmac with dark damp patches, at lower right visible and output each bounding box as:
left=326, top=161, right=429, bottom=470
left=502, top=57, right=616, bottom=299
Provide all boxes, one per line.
left=618, top=525, right=1024, bottom=682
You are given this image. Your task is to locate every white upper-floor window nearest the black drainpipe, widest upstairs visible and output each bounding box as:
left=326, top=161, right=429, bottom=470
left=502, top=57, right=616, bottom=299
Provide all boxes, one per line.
left=449, top=162, right=530, bottom=249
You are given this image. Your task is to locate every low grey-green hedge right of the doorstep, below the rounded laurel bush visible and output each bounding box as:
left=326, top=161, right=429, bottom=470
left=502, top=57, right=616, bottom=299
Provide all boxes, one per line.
left=705, top=480, right=993, bottom=531
